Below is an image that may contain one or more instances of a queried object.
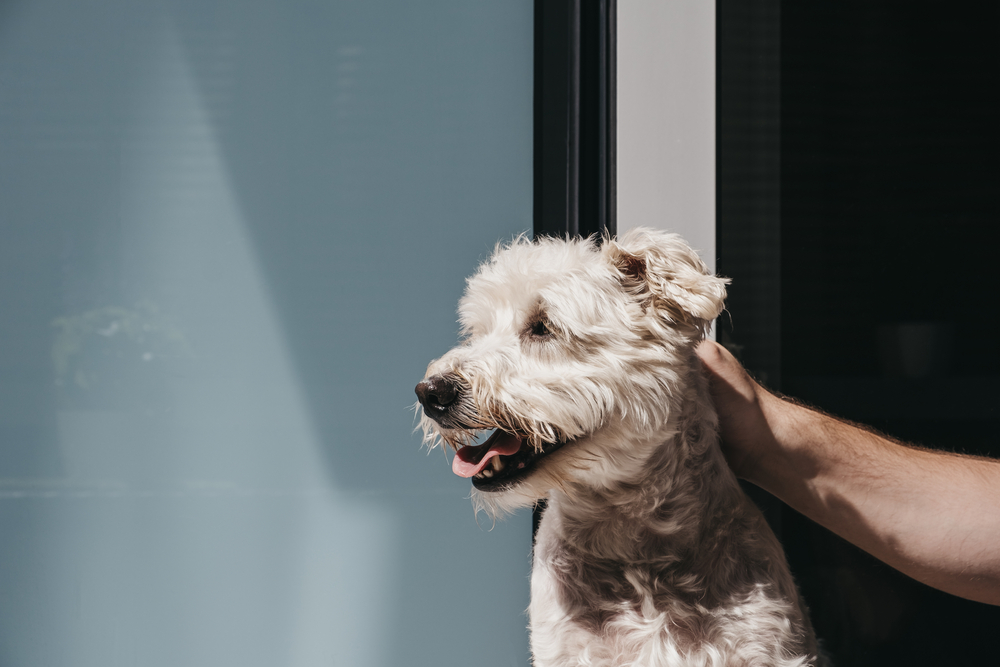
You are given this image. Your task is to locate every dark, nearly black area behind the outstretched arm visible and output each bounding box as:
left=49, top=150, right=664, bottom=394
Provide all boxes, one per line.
left=718, top=1, right=1000, bottom=666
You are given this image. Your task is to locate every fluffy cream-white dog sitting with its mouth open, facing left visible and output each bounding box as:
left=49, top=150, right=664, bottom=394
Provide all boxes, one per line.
left=416, top=229, right=817, bottom=667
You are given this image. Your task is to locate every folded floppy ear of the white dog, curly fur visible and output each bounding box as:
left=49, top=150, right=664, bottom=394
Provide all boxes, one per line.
left=601, top=227, right=729, bottom=331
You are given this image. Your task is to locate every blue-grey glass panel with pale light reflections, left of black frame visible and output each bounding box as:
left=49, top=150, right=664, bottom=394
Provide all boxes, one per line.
left=0, top=0, right=532, bottom=667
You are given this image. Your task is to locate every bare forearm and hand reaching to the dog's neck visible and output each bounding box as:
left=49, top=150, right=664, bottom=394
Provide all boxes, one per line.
left=698, top=341, right=1000, bottom=605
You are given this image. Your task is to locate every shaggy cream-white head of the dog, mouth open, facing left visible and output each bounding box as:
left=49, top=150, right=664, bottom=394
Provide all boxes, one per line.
left=416, top=229, right=728, bottom=513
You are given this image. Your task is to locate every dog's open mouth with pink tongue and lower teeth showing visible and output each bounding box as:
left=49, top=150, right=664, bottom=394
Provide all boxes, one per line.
left=451, top=429, right=566, bottom=491
